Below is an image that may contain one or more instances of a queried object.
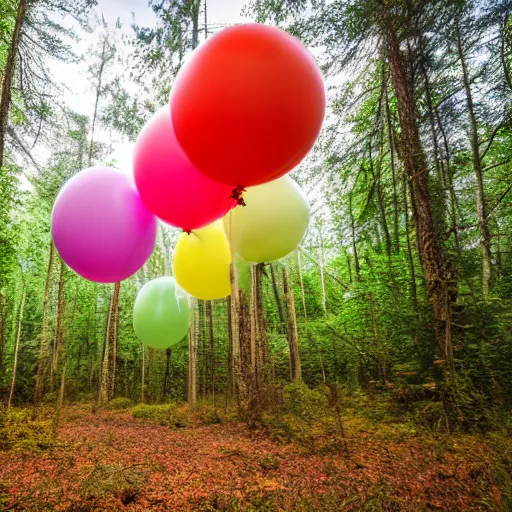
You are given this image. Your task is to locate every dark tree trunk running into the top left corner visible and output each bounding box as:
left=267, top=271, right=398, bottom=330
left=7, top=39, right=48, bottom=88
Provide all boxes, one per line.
left=0, top=0, right=27, bottom=169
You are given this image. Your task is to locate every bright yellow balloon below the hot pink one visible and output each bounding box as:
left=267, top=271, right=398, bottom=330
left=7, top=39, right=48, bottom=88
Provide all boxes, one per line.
left=173, top=221, right=231, bottom=300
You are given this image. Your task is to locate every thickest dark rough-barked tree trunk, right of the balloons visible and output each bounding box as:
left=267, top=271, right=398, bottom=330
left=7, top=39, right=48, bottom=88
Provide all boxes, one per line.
left=388, top=31, right=457, bottom=366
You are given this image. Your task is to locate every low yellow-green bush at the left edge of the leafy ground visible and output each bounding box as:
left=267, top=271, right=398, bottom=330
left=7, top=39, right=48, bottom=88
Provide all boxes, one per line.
left=0, top=409, right=54, bottom=451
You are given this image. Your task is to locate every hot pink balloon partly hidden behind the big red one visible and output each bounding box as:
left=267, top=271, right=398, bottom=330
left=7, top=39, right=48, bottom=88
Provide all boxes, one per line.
left=133, top=105, right=236, bottom=231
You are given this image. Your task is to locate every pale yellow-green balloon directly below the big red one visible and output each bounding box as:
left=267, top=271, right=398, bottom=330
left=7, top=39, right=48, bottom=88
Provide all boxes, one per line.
left=224, top=176, right=309, bottom=263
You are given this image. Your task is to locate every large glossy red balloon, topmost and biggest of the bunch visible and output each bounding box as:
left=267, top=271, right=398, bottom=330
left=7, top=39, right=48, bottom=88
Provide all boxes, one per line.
left=169, top=23, right=325, bottom=187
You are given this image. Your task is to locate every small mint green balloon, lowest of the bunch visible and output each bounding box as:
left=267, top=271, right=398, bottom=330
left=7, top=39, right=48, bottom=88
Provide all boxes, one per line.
left=133, top=277, right=190, bottom=349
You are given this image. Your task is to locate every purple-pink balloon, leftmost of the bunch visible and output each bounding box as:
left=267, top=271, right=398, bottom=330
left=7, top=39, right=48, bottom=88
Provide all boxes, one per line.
left=52, top=167, right=156, bottom=283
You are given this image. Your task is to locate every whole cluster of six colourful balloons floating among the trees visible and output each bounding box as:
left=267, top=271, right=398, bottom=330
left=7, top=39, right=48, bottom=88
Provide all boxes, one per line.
left=52, top=23, right=325, bottom=348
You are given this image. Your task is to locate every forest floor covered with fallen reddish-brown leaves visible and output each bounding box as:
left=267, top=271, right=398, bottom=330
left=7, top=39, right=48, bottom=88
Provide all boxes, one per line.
left=0, top=405, right=511, bottom=512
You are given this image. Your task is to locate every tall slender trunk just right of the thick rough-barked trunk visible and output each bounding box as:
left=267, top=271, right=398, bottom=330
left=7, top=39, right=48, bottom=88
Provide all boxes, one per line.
left=457, top=24, right=492, bottom=299
